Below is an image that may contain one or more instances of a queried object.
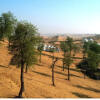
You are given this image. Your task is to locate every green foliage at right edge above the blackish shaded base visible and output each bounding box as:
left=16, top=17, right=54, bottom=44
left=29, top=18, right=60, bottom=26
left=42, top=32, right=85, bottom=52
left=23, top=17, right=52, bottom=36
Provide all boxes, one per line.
left=82, top=42, right=100, bottom=72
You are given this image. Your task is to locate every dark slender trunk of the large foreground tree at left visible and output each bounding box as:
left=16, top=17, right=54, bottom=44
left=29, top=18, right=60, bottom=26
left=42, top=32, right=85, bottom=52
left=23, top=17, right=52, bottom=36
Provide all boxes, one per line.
left=18, top=61, right=24, bottom=98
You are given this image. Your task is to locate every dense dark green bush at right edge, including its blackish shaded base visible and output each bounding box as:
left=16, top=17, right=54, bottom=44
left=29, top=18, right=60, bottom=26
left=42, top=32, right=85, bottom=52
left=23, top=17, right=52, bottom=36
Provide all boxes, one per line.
left=77, top=42, right=100, bottom=79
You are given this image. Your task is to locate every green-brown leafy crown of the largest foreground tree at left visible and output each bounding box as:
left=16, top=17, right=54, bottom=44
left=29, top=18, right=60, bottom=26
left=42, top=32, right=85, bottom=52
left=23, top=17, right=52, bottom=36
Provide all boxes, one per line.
left=11, top=22, right=37, bottom=65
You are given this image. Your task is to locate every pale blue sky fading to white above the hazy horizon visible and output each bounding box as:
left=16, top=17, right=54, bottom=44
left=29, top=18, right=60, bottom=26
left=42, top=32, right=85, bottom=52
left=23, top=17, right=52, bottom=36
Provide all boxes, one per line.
left=0, top=0, right=100, bottom=34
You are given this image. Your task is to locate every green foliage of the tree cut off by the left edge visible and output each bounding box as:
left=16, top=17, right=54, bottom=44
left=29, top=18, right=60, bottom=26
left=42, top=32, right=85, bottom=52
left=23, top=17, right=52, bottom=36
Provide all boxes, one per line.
left=0, top=12, right=17, bottom=39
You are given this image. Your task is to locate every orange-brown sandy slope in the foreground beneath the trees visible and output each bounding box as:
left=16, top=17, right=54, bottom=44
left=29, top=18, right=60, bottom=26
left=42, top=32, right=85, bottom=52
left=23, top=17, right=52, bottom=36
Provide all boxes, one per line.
left=0, top=43, right=100, bottom=98
